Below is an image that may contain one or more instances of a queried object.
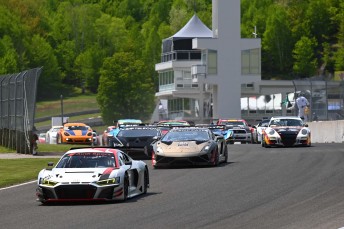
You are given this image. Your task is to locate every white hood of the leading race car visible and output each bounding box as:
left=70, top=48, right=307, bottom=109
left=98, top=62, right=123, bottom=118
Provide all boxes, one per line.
left=43, top=168, right=114, bottom=183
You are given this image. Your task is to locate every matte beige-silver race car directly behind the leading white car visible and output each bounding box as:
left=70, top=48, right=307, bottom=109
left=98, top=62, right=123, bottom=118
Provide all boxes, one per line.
left=152, top=127, right=228, bottom=168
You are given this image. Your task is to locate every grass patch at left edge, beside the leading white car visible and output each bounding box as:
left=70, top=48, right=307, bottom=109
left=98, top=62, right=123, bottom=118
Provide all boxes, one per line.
left=0, top=158, right=58, bottom=189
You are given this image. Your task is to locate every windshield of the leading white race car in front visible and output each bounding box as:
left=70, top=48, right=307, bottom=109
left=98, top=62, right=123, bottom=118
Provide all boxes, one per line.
left=56, top=153, right=116, bottom=168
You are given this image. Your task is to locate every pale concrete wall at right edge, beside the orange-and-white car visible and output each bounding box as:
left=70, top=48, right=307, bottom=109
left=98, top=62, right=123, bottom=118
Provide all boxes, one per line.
left=307, top=120, right=344, bottom=143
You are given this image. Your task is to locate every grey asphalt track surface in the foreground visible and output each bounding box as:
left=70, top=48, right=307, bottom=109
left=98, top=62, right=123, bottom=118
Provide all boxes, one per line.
left=0, top=143, right=344, bottom=229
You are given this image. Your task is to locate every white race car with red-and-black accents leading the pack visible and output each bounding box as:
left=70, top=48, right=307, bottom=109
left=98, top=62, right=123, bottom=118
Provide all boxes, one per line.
left=36, top=147, right=149, bottom=203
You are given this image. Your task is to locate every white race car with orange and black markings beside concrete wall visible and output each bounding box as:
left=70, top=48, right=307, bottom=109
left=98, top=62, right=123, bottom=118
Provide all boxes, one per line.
left=261, top=116, right=311, bottom=148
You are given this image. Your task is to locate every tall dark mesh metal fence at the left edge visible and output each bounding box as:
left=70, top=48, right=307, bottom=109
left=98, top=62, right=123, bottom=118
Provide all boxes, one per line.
left=0, top=68, right=42, bottom=154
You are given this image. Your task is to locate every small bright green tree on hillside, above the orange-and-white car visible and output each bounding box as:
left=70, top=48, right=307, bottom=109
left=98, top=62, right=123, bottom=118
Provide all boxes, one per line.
left=293, top=37, right=317, bottom=78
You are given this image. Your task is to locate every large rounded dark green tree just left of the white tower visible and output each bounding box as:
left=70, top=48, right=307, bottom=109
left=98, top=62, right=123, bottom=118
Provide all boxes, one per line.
left=97, top=52, right=154, bottom=124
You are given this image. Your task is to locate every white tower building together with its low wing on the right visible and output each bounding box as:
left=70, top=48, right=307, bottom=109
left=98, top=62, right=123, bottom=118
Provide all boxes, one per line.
left=152, top=0, right=337, bottom=124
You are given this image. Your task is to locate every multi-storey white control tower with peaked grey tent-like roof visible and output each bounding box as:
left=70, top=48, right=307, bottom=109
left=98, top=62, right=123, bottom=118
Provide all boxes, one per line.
left=155, top=0, right=261, bottom=122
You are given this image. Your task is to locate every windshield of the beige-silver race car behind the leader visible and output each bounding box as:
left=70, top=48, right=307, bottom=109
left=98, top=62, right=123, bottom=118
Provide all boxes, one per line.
left=161, top=131, right=210, bottom=141
